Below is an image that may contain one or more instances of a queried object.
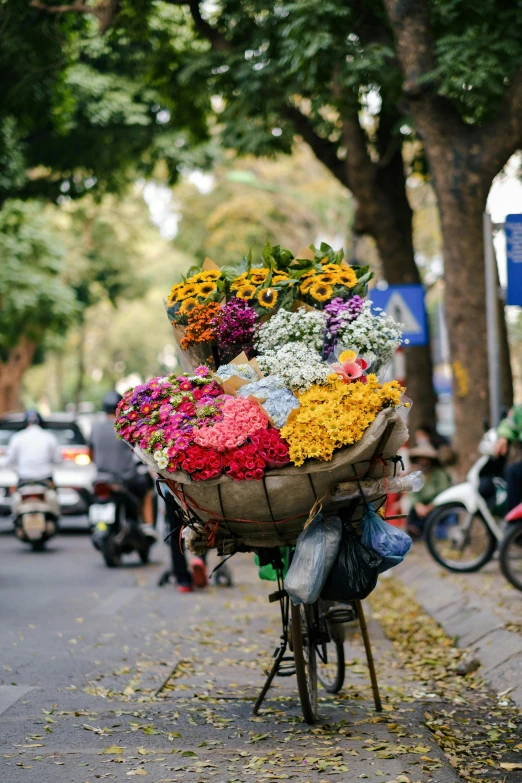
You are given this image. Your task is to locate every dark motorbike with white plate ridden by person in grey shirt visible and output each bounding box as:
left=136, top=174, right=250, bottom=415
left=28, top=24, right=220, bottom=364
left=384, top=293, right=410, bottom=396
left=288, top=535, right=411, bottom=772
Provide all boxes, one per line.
left=89, top=475, right=156, bottom=568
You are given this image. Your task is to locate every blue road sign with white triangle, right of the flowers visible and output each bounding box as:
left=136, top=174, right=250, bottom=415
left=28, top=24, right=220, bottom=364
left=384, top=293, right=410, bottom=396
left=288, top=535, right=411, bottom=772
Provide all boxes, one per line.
left=369, top=285, right=428, bottom=345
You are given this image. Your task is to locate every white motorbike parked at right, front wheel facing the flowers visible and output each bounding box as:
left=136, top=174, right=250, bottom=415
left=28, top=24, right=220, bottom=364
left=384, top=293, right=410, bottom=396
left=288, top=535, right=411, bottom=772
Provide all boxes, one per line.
left=425, top=429, right=507, bottom=573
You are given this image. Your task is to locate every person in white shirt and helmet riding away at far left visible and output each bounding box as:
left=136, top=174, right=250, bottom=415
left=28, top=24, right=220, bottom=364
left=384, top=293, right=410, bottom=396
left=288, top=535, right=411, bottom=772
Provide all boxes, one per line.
left=7, top=411, right=63, bottom=482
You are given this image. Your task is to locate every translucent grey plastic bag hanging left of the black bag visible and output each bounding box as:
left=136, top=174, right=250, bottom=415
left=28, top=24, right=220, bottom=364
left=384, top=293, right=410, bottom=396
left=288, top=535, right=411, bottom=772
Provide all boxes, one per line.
left=285, top=514, right=342, bottom=604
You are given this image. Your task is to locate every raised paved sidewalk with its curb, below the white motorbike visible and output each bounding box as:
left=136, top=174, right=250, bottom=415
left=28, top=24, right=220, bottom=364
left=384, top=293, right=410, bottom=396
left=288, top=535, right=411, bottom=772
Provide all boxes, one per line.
left=394, top=543, right=522, bottom=707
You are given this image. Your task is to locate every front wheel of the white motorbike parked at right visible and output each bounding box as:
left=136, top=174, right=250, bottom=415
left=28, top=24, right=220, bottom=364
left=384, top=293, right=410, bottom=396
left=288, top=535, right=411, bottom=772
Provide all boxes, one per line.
left=424, top=503, right=497, bottom=574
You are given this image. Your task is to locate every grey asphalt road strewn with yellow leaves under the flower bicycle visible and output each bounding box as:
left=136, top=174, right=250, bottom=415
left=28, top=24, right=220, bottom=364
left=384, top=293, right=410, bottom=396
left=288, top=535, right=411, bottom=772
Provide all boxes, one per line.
left=0, top=541, right=522, bottom=783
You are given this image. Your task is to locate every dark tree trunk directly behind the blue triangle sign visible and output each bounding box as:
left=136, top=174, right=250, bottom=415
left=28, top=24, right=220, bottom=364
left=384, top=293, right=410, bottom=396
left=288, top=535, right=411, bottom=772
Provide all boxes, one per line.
left=354, top=150, right=437, bottom=441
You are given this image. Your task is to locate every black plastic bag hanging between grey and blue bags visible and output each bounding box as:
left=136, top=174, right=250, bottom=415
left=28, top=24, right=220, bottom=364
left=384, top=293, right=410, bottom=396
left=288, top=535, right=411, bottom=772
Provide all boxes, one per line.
left=321, top=530, right=383, bottom=601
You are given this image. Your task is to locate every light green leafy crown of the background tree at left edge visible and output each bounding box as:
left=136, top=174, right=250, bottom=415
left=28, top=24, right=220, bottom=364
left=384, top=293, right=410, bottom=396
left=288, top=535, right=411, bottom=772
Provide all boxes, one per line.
left=0, top=201, right=77, bottom=360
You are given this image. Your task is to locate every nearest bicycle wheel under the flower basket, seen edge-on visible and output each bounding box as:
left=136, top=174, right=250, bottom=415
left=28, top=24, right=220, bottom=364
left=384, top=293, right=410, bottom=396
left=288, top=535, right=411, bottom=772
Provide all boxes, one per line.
left=291, top=604, right=317, bottom=723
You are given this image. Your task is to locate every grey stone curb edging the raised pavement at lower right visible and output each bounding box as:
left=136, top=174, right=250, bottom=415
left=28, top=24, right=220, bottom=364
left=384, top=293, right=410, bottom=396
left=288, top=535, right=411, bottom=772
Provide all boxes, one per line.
left=394, top=561, right=522, bottom=707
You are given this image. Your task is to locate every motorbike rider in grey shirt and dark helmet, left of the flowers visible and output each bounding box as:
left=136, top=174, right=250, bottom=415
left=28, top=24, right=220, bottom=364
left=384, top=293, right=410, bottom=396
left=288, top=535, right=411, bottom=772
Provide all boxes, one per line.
left=89, top=391, right=152, bottom=522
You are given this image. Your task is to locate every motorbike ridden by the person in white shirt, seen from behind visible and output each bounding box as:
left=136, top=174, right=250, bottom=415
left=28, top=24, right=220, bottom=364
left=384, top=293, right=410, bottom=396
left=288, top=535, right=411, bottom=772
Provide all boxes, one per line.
left=11, top=481, right=60, bottom=552
